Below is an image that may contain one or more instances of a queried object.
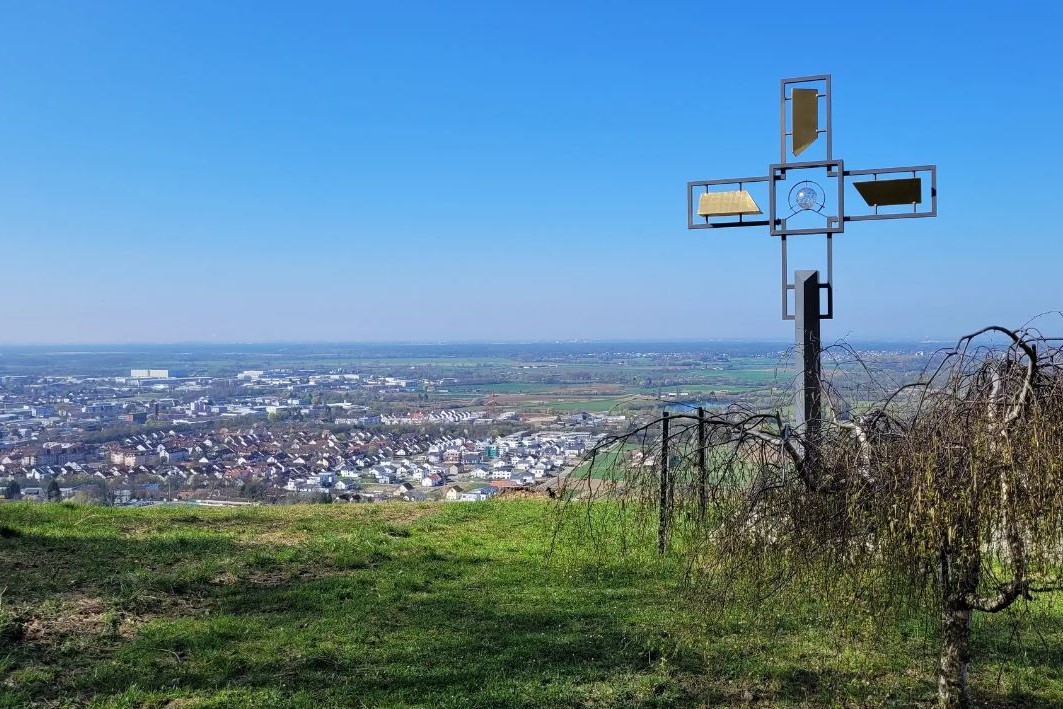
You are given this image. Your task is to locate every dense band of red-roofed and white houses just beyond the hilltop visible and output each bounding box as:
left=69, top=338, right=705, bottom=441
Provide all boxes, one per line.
left=0, top=426, right=596, bottom=496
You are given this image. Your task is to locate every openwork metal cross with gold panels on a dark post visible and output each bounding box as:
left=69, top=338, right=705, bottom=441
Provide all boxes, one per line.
left=687, top=74, right=938, bottom=434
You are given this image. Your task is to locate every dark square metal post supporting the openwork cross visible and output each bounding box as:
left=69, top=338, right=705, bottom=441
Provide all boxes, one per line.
left=794, top=271, right=822, bottom=440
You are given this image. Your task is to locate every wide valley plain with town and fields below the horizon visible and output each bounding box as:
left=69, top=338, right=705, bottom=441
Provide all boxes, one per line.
left=0, top=342, right=932, bottom=505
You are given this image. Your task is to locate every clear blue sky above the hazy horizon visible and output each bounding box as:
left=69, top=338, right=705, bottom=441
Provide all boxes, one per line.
left=0, top=0, right=1063, bottom=343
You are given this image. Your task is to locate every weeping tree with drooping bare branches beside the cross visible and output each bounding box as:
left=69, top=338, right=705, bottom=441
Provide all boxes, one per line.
left=562, top=326, right=1063, bottom=708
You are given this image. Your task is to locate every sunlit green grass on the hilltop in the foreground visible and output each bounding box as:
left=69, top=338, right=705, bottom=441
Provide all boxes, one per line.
left=0, top=501, right=1063, bottom=708
